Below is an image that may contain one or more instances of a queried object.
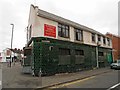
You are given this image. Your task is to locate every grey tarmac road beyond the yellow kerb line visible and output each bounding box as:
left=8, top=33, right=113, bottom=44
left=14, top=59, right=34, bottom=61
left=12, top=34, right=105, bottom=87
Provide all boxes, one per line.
left=51, top=70, right=120, bottom=90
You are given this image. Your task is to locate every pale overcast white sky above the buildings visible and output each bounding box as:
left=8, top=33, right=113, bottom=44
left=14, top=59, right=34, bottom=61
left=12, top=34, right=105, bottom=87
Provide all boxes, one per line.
left=0, top=0, right=119, bottom=51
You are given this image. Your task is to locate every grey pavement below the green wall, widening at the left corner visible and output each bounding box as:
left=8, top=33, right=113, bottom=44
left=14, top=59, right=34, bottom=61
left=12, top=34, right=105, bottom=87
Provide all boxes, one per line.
left=2, top=63, right=113, bottom=88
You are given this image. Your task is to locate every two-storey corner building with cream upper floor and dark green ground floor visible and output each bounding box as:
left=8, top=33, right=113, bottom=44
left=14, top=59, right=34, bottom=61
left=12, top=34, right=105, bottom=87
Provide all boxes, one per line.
left=24, top=5, right=112, bottom=76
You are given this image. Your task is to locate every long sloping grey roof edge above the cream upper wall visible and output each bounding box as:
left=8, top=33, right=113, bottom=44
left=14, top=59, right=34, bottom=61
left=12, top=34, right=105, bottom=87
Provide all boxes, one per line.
left=31, top=5, right=105, bottom=36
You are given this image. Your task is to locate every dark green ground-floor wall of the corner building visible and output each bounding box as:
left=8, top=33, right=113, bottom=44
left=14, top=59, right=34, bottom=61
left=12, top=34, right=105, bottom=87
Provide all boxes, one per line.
left=24, top=38, right=112, bottom=75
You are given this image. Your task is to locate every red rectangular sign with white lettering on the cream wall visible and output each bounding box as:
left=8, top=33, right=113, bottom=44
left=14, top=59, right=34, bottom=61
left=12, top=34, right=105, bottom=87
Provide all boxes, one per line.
left=44, top=24, right=56, bottom=38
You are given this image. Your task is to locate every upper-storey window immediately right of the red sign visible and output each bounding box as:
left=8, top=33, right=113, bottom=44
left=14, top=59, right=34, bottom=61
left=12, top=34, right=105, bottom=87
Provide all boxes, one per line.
left=58, top=23, right=69, bottom=38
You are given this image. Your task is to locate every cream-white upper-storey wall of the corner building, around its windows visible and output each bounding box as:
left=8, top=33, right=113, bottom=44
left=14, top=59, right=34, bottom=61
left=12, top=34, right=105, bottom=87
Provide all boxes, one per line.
left=28, top=5, right=112, bottom=48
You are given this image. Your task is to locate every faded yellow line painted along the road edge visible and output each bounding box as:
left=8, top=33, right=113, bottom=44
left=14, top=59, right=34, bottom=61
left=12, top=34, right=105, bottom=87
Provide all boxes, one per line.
left=50, top=76, right=96, bottom=88
